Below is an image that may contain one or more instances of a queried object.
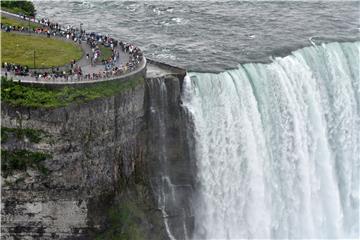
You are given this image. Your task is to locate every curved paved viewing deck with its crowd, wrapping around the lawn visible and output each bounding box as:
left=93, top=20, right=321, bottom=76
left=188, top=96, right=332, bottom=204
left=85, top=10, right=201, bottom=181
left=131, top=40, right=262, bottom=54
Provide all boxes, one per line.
left=1, top=11, right=147, bottom=87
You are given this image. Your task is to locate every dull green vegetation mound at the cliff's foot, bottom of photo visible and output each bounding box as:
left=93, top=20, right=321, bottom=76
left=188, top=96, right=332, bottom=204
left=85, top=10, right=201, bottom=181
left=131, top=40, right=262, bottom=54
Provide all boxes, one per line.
left=95, top=185, right=166, bottom=240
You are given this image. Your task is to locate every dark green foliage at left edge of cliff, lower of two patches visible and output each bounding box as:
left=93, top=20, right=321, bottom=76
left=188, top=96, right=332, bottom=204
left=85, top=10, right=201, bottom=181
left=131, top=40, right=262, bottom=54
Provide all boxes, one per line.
left=1, top=149, right=51, bottom=177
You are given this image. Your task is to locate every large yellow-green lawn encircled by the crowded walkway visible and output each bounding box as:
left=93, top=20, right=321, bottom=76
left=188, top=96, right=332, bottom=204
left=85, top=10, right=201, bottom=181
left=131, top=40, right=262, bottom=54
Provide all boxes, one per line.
left=1, top=32, right=83, bottom=68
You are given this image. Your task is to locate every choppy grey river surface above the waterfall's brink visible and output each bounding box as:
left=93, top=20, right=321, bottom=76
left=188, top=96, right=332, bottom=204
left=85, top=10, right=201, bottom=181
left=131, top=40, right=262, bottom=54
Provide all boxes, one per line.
left=35, top=1, right=360, bottom=72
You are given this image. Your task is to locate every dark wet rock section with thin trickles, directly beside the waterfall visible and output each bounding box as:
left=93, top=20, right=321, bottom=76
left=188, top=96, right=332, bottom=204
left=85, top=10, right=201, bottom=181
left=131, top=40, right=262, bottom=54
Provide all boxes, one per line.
left=145, top=76, right=195, bottom=239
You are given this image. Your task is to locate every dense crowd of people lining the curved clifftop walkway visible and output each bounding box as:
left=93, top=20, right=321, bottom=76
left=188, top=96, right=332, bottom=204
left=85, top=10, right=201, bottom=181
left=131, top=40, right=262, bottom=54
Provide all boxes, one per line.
left=1, top=12, right=143, bottom=81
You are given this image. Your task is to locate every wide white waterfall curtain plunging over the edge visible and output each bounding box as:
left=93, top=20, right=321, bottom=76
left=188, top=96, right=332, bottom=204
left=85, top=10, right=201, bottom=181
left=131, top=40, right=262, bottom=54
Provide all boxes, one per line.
left=183, top=42, right=360, bottom=239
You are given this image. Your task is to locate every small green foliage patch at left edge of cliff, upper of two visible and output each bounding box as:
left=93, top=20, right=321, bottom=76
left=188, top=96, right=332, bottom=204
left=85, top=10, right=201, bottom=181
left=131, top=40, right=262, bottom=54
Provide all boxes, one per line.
left=1, top=127, right=44, bottom=143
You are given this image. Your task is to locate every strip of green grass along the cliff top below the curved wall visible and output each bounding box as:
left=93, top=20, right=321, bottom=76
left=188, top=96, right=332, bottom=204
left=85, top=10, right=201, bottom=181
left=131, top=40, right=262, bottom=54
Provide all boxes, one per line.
left=1, top=77, right=144, bottom=108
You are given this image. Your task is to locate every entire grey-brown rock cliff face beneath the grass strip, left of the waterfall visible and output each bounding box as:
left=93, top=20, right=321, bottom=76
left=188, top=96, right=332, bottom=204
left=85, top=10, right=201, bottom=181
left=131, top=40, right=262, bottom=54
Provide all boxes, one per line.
left=1, top=69, right=193, bottom=239
